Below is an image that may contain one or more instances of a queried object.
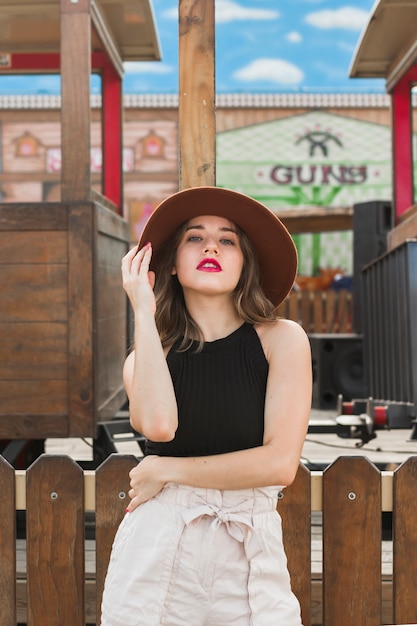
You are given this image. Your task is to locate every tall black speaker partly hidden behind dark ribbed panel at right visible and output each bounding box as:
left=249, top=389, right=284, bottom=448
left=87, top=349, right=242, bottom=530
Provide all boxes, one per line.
left=352, top=200, right=393, bottom=333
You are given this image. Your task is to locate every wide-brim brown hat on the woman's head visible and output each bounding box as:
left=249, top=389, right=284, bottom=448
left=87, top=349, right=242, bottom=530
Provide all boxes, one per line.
left=139, top=187, right=297, bottom=306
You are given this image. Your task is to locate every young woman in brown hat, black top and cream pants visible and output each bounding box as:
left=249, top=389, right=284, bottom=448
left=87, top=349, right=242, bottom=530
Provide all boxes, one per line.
left=102, top=187, right=311, bottom=626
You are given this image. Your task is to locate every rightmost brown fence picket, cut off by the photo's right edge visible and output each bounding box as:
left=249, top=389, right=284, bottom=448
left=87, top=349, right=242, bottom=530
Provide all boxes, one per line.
left=393, top=456, right=417, bottom=624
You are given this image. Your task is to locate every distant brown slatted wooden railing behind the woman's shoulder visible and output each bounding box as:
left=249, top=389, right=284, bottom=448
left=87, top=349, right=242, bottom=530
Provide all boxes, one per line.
left=278, top=289, right=353, bottom=333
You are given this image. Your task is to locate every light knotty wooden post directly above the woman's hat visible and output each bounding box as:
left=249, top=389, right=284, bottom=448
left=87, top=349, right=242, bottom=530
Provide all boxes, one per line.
left=178, top=0, right=216, bottom=189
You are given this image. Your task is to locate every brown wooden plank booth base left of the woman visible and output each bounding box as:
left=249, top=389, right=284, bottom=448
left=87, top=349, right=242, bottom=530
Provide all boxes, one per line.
left=0, top=202, right=129, bottom=439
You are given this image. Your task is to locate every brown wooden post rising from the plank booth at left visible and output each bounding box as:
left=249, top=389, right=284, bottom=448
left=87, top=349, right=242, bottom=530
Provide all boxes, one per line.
left=61, top=0, right=91, bottom=202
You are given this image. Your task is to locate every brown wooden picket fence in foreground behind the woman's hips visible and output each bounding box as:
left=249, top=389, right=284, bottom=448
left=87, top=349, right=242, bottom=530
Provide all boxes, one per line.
left=0, top=454, right=417, bottom=626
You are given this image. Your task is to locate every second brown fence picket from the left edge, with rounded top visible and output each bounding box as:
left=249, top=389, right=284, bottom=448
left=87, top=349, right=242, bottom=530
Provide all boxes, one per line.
left=26, top=455, right=85, bottom=626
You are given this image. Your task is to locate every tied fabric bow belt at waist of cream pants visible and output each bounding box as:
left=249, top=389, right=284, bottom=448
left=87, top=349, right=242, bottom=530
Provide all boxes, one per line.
left=182, top=504, right=262, bottom=560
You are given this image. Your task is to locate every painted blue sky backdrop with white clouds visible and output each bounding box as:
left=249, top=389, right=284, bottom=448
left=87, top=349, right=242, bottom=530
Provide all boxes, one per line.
left=0, top=0, right=385, bottom=94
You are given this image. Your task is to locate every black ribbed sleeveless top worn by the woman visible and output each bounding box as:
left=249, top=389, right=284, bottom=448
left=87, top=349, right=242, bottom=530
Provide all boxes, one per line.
left=146, top=323, right=268, bottom=456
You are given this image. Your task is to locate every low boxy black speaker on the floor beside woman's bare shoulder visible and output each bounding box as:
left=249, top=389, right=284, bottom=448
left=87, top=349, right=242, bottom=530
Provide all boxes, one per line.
left=309, top=334, right=367, bottom=409
